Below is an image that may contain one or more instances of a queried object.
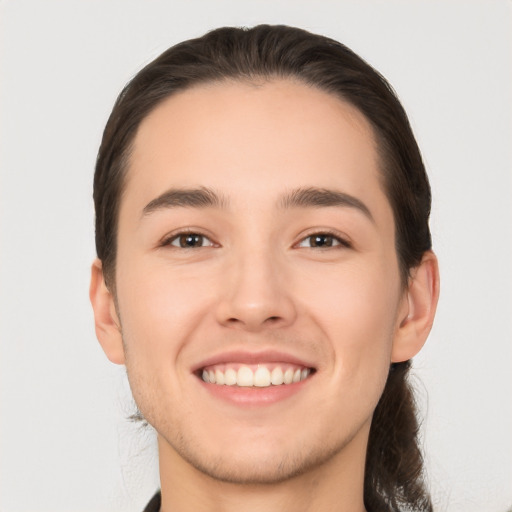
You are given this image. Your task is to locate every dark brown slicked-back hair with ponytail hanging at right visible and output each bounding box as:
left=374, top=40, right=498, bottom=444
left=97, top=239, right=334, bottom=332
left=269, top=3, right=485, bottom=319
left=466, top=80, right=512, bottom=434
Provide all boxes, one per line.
left=94, top=25, right=432, bottom=512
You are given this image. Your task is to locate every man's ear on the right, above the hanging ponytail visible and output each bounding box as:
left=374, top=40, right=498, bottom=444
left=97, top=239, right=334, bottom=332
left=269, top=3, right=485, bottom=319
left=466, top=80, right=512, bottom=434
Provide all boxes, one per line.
left=391, top=251, right=439, bottom=363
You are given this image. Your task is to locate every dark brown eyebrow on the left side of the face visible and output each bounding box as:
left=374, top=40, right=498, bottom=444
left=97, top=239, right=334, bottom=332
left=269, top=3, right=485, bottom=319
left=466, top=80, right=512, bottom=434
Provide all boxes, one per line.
left=142, top=187, right=228, bottom=216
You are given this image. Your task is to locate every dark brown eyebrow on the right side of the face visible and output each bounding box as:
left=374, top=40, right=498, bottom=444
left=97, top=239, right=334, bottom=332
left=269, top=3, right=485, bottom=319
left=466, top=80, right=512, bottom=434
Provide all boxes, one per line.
left=279, top=187, right=375, bottom=223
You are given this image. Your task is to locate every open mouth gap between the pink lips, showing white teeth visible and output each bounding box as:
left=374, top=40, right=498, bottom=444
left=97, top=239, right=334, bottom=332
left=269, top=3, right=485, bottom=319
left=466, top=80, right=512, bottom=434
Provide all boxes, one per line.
left=197, top=362, right=315, bottom=388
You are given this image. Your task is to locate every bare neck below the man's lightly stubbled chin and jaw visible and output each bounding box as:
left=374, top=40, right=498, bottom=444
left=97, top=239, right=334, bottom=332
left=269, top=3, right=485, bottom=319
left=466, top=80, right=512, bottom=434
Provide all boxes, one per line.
left=158, top=429, right=368, bottom=512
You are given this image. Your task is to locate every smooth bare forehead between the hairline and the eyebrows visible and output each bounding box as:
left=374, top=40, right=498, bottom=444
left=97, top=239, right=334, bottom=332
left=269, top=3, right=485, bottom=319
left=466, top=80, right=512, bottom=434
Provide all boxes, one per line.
left=125, top=80, right=390, bottom=217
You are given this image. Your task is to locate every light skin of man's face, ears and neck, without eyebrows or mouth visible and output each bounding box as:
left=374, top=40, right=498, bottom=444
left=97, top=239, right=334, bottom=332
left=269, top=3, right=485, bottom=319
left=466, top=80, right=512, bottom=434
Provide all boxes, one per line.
left=91, top=81, right=438, bottom=512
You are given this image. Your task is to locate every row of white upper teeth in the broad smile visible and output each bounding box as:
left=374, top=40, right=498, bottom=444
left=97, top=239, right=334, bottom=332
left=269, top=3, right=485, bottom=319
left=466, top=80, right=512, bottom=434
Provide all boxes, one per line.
left=202, top=365, right=310, bottom=388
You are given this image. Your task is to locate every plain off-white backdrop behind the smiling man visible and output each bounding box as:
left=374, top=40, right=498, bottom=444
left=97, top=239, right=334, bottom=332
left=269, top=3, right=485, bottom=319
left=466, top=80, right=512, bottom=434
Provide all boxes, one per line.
left=0, top=0, right=512, bottom=512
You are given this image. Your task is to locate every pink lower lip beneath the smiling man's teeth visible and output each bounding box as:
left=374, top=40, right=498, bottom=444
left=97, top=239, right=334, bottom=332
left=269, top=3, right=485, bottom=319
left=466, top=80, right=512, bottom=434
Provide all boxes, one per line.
left=199, top=376, right=312, bottom=406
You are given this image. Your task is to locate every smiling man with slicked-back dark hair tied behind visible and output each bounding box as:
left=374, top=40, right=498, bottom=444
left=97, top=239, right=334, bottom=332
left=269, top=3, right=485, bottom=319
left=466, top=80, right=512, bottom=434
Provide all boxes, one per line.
left=90, top=26, right=439, bottom=512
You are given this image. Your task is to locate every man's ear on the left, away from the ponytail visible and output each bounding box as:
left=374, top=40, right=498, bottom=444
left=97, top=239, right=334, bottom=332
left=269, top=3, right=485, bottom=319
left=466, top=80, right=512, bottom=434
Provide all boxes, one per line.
left=89, top=259, right=124, bottom=364
